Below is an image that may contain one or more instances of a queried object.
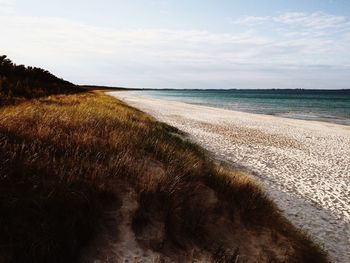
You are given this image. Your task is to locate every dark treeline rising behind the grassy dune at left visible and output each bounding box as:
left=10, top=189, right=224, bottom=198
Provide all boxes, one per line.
left=0, top=55, right=80, bottom=101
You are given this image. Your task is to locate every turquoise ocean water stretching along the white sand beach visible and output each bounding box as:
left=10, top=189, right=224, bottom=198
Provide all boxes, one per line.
left=133, top=90, right=350, bottom=125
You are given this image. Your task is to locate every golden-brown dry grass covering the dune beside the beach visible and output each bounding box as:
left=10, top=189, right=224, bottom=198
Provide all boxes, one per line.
left=0, top=92, right=327, bottom=263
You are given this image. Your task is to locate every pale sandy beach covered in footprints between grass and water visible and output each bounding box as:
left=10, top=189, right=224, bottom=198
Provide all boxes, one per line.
left=108, top=91, right=350, bottom=263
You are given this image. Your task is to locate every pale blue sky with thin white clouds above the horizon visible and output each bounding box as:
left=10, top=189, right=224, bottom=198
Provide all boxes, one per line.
left=0, top=0, right=350, bottom=89
